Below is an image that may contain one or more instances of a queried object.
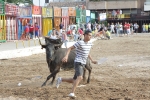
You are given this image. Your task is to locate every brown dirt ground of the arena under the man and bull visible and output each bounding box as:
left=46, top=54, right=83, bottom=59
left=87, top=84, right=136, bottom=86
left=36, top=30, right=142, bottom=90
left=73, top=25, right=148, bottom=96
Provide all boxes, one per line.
left=0, top=34, right=150, bottom=100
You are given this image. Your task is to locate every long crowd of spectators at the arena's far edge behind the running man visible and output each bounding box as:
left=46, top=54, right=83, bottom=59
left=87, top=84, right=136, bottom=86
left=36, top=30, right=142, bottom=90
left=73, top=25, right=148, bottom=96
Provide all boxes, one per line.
left=46, top=22, right=139, bottom=48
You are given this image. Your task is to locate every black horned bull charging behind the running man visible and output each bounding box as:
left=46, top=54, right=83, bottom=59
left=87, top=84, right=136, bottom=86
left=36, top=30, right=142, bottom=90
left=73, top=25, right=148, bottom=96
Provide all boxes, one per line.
left=39, top=38, right=92, bottom=86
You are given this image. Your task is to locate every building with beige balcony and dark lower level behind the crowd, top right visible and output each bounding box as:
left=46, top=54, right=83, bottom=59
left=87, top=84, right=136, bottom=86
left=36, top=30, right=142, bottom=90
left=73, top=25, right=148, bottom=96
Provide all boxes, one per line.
left=44, top=0, right=150, bottom=32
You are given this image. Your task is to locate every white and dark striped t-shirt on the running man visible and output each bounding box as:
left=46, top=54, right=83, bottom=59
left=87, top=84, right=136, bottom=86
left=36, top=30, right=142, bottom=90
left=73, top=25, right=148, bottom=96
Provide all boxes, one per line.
left=73, top=41, right=93, bottom=64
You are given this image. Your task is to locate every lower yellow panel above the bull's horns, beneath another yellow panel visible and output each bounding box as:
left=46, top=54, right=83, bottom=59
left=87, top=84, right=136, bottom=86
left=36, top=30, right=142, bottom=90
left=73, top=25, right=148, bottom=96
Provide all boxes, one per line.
left=42, top=18, right=53, bottom=36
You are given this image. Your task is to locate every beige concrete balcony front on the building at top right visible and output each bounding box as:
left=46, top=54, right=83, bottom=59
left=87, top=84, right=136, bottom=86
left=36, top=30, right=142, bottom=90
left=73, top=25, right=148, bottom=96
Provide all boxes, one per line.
left=86, top=0, right=138, bottom=10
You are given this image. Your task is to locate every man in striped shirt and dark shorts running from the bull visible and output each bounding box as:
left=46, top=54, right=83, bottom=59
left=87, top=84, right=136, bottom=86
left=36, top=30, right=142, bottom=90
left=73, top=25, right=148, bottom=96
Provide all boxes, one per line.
left=56, top=30, right=97, bottom=97
